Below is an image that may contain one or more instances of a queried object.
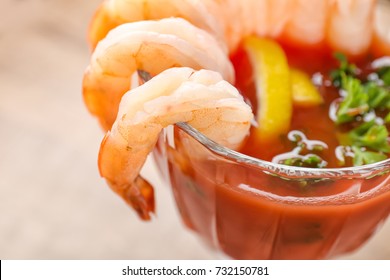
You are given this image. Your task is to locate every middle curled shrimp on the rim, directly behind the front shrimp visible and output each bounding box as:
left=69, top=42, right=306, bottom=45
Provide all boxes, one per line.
left=83, top=18, right=234, bottom=130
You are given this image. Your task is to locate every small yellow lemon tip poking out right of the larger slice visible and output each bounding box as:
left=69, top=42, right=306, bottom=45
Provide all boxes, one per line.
left=290, top=68, right=324, bottom=107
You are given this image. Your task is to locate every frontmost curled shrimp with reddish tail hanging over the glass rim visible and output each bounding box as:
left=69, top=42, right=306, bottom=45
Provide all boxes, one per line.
left=98, top=67, right=253, bottom=220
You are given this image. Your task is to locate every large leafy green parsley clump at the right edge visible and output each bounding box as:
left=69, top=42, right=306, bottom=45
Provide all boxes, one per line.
left=330, top=54, right=390, bottom=166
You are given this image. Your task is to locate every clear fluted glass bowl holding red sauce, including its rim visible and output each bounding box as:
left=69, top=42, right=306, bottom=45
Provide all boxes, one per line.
left=154, top=2, right=390, bottom=259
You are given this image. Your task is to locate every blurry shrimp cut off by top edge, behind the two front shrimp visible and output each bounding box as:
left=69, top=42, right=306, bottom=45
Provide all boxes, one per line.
left=88, top=0, right=224, bottom=49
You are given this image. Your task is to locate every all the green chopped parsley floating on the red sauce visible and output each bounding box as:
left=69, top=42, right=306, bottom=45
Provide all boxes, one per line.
left=278, top=53, right=390, bottom=168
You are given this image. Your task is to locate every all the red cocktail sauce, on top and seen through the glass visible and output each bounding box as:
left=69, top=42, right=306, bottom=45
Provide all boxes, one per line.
left=155, top=44, right=390, bottom=259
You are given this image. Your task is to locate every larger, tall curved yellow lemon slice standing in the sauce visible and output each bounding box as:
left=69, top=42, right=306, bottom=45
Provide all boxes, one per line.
left=243, top=36, right=293, bottom=142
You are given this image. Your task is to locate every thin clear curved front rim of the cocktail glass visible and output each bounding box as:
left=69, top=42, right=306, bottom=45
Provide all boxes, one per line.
left=176, top=122, right=390, bottom=179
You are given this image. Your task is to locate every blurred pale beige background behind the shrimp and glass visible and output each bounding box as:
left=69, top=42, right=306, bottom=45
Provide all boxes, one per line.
left=0, top=0, right=390, bottom=259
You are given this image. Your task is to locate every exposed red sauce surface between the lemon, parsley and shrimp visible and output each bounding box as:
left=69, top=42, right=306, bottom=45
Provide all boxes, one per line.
left=231, top=45, right=386, bottom=168
